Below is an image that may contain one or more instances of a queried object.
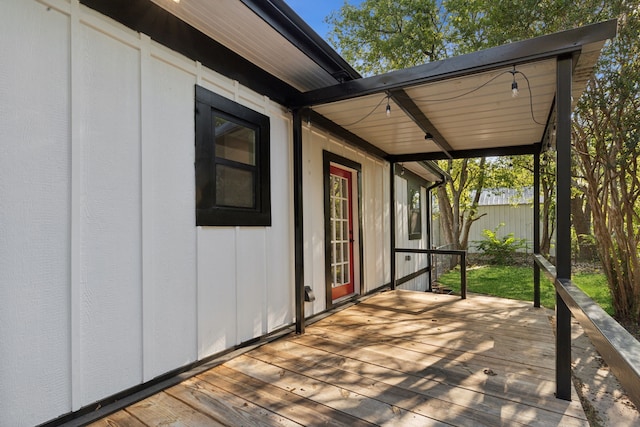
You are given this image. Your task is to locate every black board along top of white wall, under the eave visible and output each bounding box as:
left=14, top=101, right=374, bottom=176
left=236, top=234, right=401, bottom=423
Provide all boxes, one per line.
left=80, top=0, right=300, bottom=105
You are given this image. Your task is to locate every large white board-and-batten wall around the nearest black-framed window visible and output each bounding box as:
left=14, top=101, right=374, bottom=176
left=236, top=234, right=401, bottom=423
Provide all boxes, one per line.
left=0, top=0, right=294, bottom=426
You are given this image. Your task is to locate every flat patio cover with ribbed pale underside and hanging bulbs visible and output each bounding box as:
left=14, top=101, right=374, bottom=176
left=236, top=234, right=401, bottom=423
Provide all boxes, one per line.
left=296, top=20, right=616, bottom=161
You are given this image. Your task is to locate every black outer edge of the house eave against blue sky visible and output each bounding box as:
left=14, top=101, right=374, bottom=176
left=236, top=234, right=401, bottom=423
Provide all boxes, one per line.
left=240, top=0, right=362, bottom=82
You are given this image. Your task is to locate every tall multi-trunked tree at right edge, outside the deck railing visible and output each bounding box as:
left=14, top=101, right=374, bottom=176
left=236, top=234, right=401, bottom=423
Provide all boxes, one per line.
left=573, top=0, right=640, bottom=322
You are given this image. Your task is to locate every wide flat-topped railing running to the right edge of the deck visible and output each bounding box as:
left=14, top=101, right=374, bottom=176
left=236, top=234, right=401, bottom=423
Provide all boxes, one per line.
left=535, top=255, right=640, bottom=408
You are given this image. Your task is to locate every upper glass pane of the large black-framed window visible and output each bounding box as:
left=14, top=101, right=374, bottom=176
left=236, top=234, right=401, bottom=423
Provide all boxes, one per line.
left=215, top=117, right=256, bottom=166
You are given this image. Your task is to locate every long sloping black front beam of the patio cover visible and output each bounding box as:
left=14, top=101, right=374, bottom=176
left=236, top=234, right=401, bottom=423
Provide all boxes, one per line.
left=289, top=19, right=617, bottom=107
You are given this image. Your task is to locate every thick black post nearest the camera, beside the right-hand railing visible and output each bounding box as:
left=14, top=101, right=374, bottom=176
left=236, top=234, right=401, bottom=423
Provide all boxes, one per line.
left=556, top=55, right=573, bottom=400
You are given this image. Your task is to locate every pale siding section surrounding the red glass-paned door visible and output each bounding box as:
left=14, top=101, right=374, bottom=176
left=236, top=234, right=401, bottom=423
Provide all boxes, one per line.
left=303, top=124, right=391, bottom=316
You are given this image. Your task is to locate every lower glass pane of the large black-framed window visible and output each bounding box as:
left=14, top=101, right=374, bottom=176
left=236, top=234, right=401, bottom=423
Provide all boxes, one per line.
left=216, top=165, right=255, bottom=208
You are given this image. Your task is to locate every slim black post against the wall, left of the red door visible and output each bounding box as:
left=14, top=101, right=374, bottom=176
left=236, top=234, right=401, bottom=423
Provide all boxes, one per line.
left=293, top=109, right=305, bottom=334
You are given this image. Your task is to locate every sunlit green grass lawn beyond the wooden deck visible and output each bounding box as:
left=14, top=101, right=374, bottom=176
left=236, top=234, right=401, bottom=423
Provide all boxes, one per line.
left=438, top=265, right=613, bottom=315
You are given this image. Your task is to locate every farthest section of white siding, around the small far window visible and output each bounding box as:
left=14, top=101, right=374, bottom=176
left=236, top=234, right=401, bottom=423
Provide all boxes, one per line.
left=395, top=175, right=429, bottom=291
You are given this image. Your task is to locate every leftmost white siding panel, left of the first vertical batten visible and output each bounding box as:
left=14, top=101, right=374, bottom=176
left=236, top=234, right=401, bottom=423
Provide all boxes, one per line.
left=0, top=0, right=71, bottom=426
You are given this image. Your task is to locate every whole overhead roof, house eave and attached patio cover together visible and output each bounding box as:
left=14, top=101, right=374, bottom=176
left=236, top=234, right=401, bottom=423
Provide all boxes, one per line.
left=95, top=0, right=616, bottom=181
